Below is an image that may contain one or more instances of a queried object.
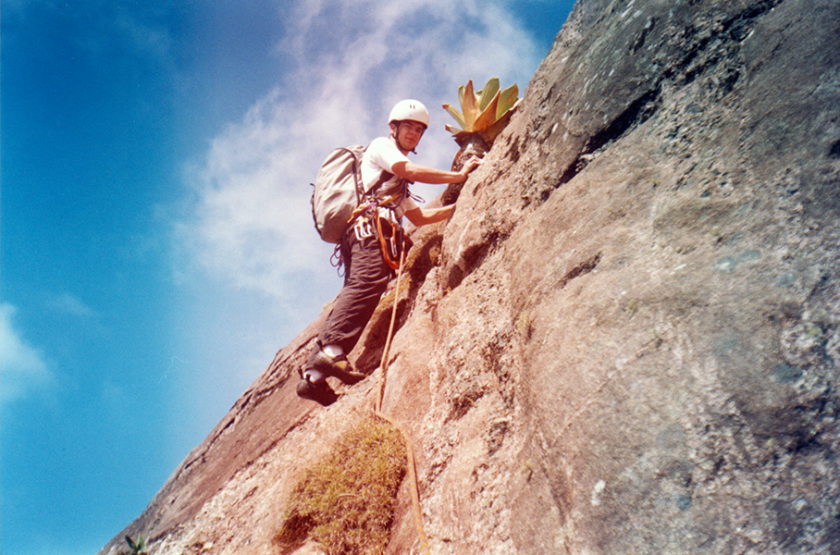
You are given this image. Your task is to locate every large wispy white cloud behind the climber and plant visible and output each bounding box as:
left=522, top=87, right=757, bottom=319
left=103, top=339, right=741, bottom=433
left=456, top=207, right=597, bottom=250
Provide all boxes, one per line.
left=176, top=0, right=541, bottom=302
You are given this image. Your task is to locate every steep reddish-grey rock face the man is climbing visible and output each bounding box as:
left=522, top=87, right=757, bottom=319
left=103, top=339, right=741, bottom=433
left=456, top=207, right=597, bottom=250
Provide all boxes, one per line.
left=101, top=0, right=840, bottom=555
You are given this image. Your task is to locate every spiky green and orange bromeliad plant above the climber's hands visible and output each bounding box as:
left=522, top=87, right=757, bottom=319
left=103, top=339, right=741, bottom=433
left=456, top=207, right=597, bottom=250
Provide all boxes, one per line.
left=443, top=77, right=519, bottom=147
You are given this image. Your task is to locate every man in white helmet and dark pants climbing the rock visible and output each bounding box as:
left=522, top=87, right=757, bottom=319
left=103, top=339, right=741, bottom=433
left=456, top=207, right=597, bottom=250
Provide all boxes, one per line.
left=297, top=100, right=480, bottom=406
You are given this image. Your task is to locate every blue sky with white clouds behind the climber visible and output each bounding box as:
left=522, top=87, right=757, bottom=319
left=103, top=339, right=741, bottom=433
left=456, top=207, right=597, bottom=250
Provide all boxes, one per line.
left=0, top=0, right=572, bottom=555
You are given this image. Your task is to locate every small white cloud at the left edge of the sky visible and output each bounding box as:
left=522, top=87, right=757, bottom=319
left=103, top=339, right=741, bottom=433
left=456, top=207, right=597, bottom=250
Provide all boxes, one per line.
left=0, top=303, right=55, bottom=404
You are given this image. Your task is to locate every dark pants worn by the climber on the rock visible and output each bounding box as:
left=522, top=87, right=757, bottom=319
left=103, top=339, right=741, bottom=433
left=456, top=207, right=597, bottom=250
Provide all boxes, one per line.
left=318, top=227, right=394, bottom=353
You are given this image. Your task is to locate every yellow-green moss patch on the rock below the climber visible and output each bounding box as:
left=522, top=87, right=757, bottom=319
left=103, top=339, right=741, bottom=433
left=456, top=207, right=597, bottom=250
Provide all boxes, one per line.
left=275, top=419, right=406, bottom=555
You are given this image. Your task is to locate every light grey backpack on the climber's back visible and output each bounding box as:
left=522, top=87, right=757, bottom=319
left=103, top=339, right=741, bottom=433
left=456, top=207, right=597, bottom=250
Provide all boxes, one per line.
left=310, top=145, right=367, bottom=243
